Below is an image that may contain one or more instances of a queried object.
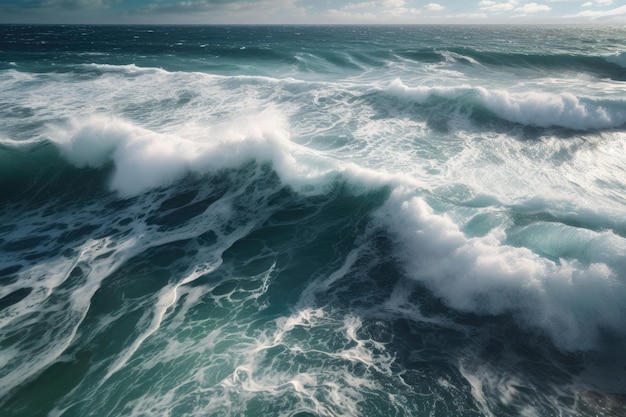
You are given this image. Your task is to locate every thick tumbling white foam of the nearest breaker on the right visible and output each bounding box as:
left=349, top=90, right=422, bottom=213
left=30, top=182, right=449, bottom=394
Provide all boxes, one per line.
left=381, top=189, right=626, bottom=350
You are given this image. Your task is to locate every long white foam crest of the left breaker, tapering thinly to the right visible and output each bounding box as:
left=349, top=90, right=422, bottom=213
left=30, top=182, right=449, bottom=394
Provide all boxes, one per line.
left=49, top=109, right=425, bottom=197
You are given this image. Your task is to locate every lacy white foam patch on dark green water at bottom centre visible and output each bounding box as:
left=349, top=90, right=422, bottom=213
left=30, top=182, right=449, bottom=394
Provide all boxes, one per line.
left=220, top=308, right=392, bottom=416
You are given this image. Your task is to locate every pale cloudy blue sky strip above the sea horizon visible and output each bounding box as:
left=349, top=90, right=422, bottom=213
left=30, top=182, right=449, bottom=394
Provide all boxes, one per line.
left=0, top=0, right=626, bottom=24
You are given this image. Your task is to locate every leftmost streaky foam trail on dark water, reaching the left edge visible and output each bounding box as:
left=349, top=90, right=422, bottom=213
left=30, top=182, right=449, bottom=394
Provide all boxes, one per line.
left=0, top=234, right=136, bottom=398
